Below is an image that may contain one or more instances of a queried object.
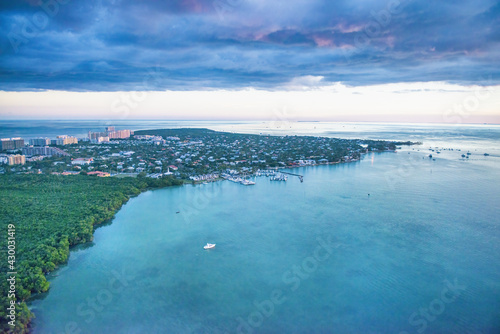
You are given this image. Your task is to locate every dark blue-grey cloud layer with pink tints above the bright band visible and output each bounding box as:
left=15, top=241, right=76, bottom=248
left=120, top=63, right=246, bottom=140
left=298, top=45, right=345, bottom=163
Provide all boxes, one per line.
left=0, top=0, right=500, bottom=91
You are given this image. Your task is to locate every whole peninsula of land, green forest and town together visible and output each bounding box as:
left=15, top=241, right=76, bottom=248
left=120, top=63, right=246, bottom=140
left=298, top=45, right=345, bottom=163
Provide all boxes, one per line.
left=0, top=129, right=413, bottom=333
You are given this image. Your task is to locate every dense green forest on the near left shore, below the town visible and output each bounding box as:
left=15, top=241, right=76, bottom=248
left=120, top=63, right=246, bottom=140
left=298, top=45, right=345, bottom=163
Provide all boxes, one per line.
left=0, top=174, right=182, bottom=333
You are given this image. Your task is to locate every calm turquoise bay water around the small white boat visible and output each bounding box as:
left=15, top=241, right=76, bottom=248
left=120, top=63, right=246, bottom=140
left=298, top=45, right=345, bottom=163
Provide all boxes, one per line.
left=18, top=123, right=500, bottom=334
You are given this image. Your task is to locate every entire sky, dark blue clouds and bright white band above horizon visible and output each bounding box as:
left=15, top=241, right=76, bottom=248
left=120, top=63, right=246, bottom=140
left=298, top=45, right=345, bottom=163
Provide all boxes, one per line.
left=0, top=0, right=500, bottom=123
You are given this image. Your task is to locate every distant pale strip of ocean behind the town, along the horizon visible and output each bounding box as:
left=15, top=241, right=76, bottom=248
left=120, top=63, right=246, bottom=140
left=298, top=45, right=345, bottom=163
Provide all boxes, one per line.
left=0, top=120, right=500, bottom=147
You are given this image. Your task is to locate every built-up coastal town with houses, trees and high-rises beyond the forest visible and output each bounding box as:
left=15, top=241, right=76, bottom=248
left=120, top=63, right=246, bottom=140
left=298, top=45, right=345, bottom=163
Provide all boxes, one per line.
left=0, top=127, right=411, bottom=185
